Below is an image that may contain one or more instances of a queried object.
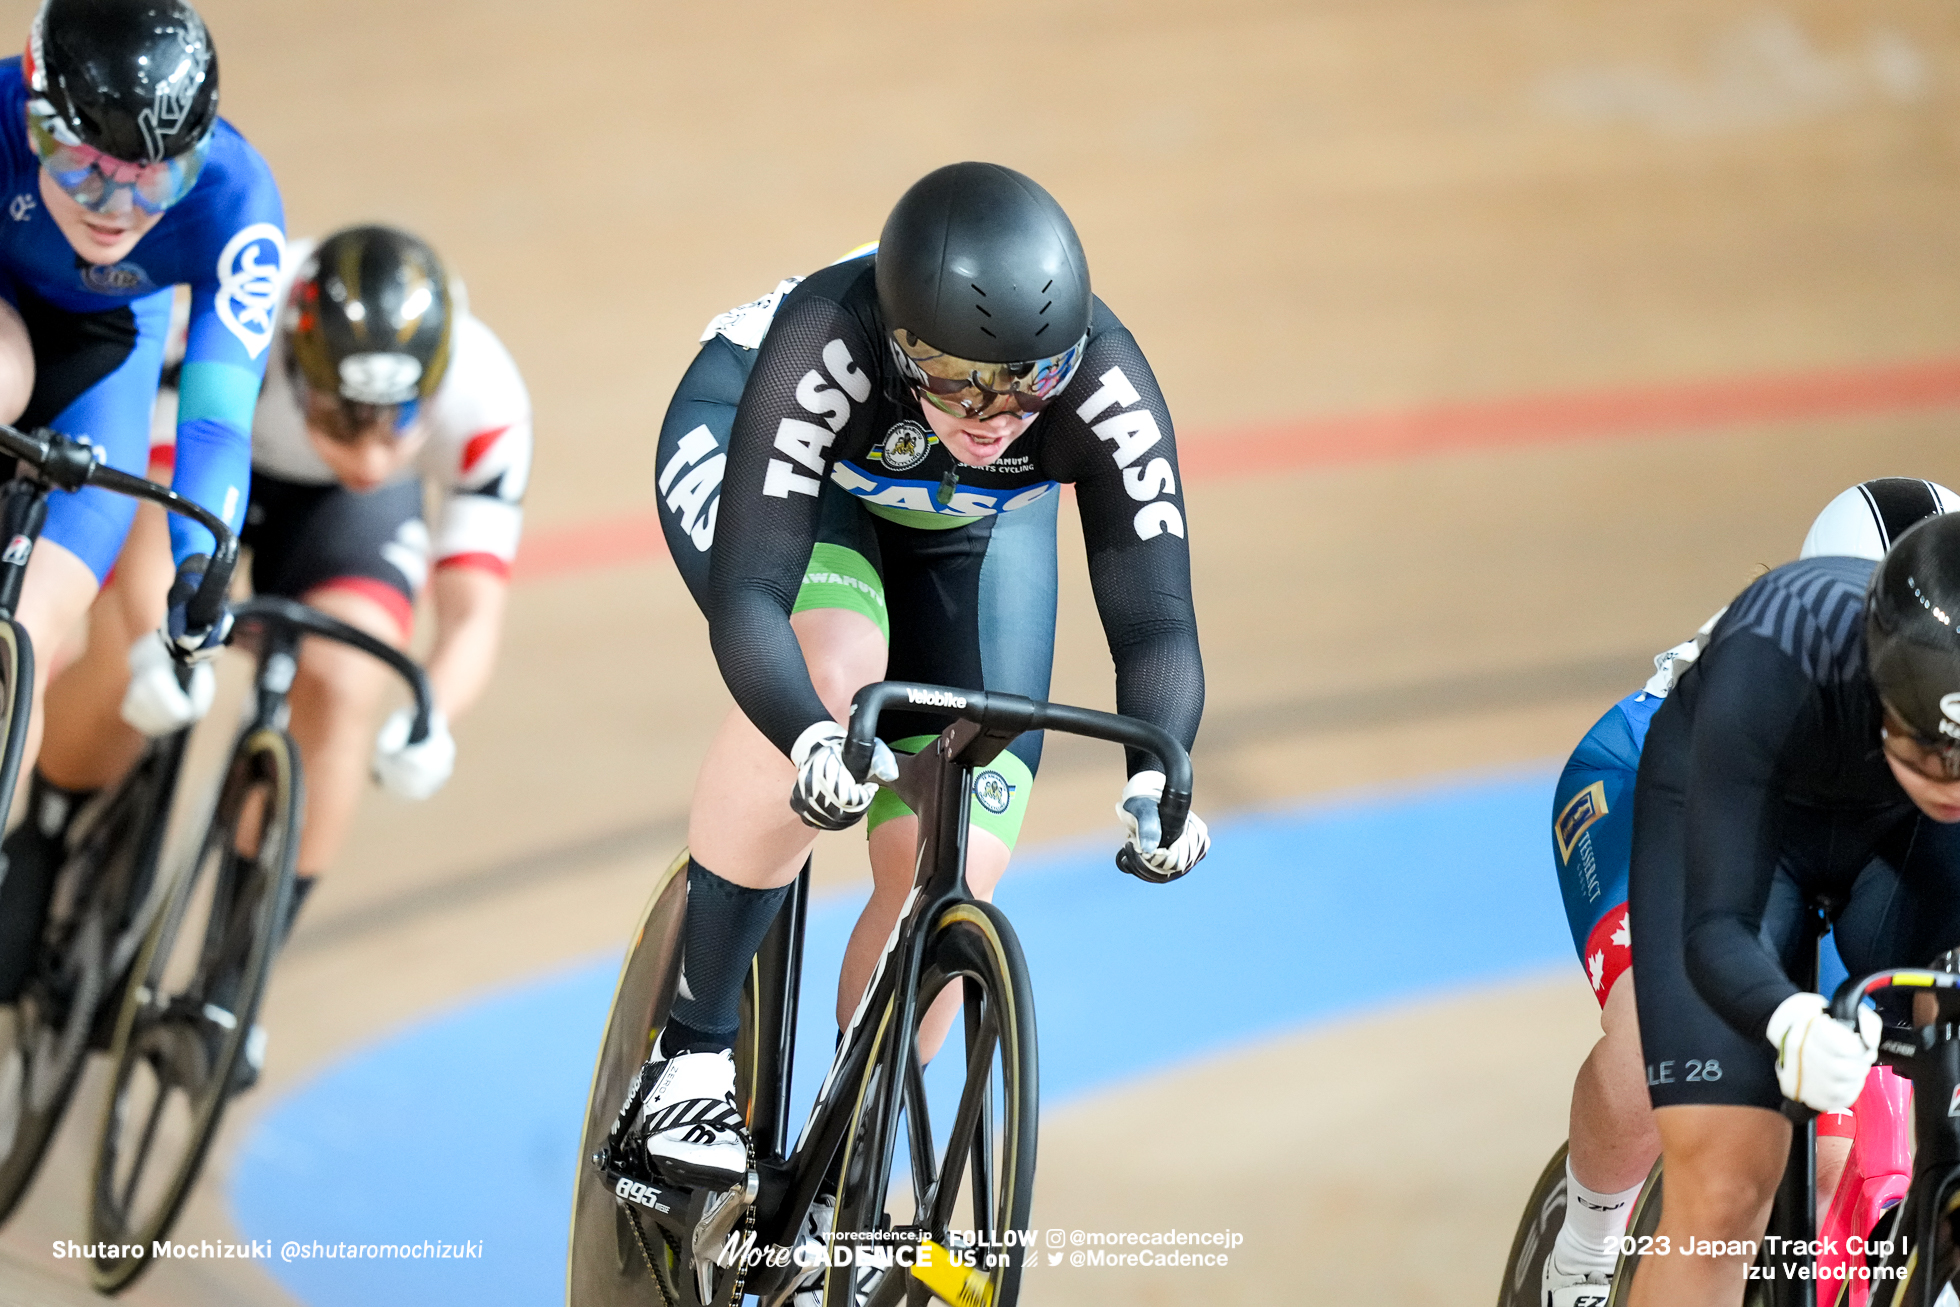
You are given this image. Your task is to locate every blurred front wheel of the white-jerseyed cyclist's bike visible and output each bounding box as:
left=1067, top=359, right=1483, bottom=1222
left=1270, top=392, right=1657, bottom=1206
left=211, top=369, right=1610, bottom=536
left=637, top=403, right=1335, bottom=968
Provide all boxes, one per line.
left=88, top=729, right=302, bottom=1293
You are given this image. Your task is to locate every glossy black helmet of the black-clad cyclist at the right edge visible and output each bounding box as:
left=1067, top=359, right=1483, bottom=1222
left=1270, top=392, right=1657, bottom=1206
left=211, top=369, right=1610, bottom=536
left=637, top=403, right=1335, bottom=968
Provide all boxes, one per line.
left=1864, top=513, right=1960, bottom=760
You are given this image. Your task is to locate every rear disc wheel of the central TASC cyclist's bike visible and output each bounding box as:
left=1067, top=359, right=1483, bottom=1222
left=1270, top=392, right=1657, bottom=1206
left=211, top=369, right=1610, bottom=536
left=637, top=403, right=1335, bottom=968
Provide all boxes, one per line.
left=564, top=848, right=688, bottom=1307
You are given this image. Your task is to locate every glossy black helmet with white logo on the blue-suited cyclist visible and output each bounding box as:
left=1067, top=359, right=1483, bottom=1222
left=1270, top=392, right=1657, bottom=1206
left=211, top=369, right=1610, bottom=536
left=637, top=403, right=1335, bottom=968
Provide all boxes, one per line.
left=24, top=0, right=218, bottom=165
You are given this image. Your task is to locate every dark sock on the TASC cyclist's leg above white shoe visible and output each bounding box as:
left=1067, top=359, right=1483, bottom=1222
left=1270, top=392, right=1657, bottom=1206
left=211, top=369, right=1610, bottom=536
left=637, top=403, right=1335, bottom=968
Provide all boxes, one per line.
left=661, top=858, right=790, bottom=1056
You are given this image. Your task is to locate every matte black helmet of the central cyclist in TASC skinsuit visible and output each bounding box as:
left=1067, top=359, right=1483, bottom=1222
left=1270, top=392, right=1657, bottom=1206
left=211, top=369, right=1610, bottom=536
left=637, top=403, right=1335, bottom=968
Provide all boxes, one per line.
left=878, top=163, right=1092, bottom=363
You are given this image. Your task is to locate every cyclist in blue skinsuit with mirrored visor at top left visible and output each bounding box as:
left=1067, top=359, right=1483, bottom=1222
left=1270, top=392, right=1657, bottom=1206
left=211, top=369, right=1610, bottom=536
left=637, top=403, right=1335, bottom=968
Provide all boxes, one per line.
left=0, top=0, right=286, bottom=1001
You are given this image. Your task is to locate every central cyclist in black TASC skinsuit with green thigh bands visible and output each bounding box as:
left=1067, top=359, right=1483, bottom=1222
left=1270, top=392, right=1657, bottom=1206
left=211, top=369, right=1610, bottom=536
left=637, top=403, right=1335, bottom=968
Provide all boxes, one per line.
left=639, top=163, right=1207, bottom=1186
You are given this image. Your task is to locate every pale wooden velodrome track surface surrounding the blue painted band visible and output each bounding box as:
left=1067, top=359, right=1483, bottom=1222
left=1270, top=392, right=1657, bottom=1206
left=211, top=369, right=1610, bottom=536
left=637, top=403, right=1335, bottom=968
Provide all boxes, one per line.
left=0, top=0, right=1960, bottom=1307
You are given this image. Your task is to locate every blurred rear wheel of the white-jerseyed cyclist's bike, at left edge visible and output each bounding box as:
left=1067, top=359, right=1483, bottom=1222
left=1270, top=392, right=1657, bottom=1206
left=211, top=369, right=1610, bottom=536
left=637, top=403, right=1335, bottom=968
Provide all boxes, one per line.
left=0, top=736, right=182, bottom=1221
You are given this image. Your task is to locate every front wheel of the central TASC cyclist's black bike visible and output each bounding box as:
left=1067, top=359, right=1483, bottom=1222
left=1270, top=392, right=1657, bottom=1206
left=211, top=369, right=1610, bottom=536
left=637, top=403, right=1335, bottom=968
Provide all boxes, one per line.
left=823, top=901, right=1041, bottom=1307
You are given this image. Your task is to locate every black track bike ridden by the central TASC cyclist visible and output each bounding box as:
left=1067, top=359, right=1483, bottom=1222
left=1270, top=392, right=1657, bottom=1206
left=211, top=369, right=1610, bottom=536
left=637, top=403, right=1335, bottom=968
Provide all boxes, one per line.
left=566, top=682, right=1192, bottom=1307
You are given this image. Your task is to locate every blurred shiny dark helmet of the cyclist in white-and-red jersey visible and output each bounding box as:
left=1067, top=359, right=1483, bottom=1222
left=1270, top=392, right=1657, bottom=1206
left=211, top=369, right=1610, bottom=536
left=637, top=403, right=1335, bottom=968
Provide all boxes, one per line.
left=286, top=227, right=455, bottom=404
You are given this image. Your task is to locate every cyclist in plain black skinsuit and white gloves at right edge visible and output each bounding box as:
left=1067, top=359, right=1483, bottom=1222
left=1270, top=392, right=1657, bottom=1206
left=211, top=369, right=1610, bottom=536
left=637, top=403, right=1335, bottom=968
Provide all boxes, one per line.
left=1629, top=513, right=1960, bottom=1307
